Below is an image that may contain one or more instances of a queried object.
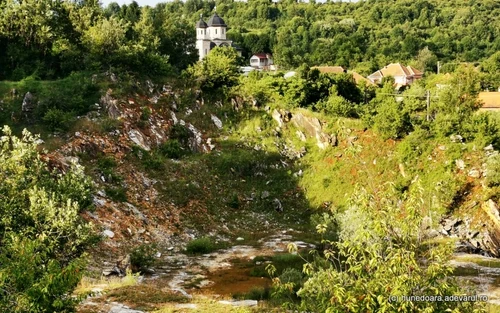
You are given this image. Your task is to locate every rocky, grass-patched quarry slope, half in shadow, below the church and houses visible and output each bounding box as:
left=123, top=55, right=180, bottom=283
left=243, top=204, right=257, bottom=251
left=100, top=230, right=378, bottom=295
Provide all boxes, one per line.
left=1, top=74, right=500, bottom=312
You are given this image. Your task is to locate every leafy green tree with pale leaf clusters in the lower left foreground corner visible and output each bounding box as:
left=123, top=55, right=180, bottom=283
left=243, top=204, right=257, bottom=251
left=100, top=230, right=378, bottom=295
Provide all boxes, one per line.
left=0, top=126, right=96, bottom=313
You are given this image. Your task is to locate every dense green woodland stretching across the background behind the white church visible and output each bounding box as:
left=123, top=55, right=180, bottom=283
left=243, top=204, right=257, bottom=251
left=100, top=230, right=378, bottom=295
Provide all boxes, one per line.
left=0, top=0, right=500, bottom=80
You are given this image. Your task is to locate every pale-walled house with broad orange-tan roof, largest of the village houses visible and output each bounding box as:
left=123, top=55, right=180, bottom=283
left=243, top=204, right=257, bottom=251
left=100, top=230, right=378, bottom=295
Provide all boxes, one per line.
left=368, top=63, right=423, bottom=88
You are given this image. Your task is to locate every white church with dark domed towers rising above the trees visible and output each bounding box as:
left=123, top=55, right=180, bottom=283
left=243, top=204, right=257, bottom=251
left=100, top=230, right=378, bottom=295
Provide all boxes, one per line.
left=196, top=13, right=241, bottom=60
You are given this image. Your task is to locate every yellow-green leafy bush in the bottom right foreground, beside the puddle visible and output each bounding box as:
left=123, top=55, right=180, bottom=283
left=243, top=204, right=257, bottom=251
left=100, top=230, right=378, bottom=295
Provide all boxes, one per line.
left=286, top=186, right=484, bottom=312
